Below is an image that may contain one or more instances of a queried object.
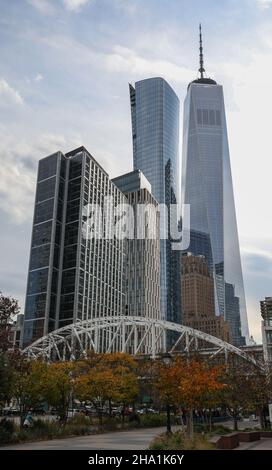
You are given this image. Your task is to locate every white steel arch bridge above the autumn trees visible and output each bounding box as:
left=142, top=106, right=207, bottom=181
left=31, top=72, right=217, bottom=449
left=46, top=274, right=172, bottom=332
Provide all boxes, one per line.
left=23, top=316, right=258, bottom=366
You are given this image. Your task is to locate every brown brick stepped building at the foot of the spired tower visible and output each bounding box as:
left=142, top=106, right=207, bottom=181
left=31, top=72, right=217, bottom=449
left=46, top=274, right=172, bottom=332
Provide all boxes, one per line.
left=181, top=253, right=230, bottom=342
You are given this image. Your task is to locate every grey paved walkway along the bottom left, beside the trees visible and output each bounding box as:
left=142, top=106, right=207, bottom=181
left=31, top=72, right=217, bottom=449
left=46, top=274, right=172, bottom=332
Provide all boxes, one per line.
left=0, top=426, right=179, bottom=450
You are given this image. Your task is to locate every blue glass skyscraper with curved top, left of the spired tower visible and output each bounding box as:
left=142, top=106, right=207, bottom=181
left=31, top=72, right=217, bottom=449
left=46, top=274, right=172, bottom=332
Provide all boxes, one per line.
left=129, top=77, right=181, bottom=323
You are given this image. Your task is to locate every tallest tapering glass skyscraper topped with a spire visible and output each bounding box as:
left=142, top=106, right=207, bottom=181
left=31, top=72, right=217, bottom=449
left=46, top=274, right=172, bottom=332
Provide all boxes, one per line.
left=181, top=30, right=249, bottom=346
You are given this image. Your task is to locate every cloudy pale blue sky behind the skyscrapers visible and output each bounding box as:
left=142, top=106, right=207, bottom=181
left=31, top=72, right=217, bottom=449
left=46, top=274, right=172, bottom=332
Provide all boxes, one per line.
left=0, top=0, right=272, bottom=343
